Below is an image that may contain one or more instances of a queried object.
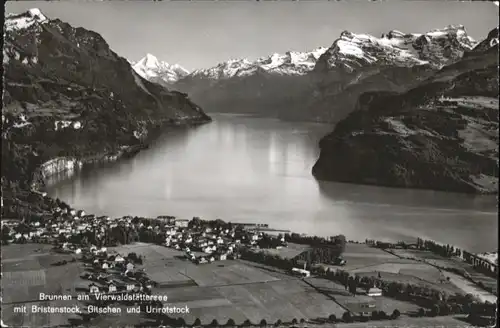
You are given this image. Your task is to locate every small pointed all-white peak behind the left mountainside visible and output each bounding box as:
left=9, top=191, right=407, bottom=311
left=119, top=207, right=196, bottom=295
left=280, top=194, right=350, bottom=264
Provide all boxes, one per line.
left=131, top=54, right=189, bottom=86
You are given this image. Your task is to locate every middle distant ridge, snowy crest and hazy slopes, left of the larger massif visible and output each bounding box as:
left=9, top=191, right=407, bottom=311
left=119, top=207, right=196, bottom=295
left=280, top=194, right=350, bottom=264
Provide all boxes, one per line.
left=172, top=48, right=326, bottom=116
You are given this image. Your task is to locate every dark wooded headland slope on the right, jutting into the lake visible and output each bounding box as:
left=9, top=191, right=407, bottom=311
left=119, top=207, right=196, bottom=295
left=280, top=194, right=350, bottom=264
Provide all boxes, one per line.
left=313, top=30, right=499, bottom=193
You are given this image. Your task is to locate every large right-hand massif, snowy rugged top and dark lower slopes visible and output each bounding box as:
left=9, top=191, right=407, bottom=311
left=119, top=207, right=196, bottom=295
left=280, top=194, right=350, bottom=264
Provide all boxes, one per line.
left=296, top=25, right=477, bottom=122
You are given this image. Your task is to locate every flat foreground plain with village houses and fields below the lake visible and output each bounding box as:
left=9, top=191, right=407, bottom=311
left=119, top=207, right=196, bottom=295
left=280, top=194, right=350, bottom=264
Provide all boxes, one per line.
left=2, top=198, right=496, bottom=327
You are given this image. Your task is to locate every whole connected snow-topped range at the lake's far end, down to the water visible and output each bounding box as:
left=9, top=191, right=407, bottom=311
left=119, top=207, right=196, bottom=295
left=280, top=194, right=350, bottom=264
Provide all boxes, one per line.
left=173, top=25, right=477, bottom=122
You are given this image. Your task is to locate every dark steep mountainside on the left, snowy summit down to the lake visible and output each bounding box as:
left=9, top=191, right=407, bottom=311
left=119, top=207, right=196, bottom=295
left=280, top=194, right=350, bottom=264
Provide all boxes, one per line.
left=2, top=9, right=209, bottom=215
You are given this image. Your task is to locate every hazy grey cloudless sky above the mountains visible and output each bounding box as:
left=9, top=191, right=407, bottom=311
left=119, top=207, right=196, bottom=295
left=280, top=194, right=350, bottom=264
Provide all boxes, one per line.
left=5, top=0, right=498, bottom=70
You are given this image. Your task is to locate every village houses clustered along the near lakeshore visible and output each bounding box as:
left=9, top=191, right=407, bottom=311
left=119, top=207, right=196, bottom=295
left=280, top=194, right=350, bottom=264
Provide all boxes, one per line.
left=2, top=207, right=285, bottom=292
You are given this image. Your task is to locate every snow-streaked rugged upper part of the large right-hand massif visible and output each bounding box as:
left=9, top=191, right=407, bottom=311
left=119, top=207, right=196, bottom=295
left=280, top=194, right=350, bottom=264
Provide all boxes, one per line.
left=317, top=25, right=477, bottom=70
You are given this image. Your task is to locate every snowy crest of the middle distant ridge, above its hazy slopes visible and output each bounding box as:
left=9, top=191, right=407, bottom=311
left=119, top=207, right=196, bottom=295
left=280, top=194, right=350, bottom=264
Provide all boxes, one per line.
left=190, top=48, right=327, bottom=79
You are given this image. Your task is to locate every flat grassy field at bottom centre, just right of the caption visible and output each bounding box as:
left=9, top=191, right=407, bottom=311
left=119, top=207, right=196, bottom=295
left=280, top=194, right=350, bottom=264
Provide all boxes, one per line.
left=162, top=278, right=343, bottom=324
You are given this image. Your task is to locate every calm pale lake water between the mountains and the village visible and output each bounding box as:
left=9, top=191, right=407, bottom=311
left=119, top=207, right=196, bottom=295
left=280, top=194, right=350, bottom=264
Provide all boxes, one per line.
left=48, top=114, right=498, bottom=252
